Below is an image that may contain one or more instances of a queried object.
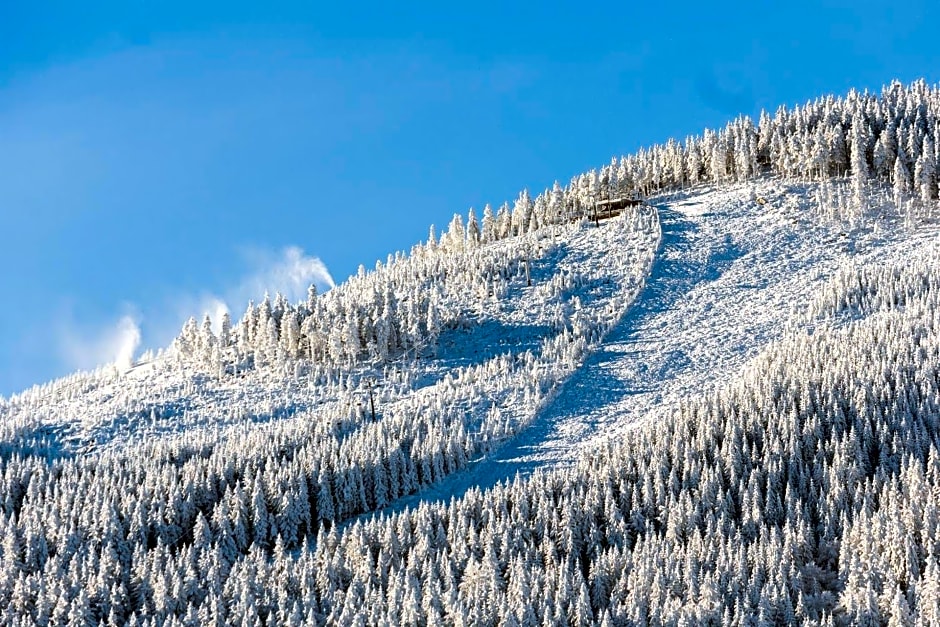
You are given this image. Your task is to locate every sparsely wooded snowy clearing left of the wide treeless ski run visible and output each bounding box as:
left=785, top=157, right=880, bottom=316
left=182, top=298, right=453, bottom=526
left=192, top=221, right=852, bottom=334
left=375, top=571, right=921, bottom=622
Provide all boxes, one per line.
left=0, top=208, right=659, bottom=466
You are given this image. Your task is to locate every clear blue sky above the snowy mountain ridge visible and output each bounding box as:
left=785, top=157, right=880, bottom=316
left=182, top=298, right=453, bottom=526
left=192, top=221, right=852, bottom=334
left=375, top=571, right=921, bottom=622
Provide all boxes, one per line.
left=0, top=0, right=940, bottom=394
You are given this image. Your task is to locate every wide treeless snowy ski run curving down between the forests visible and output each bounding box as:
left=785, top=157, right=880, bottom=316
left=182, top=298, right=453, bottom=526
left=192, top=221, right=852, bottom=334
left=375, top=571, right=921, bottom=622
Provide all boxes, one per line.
left=362, top=179, right=930, bottom=518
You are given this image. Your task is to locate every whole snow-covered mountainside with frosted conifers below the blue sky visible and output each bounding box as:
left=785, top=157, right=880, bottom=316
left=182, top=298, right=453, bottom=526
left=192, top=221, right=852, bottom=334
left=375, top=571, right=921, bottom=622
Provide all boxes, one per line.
left=0, top=83, right=940, bottom=625
